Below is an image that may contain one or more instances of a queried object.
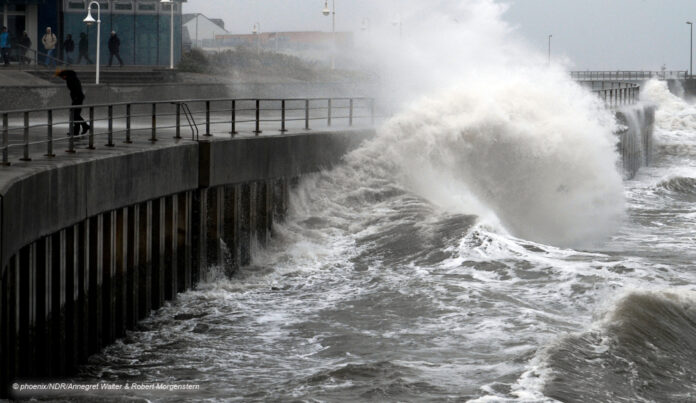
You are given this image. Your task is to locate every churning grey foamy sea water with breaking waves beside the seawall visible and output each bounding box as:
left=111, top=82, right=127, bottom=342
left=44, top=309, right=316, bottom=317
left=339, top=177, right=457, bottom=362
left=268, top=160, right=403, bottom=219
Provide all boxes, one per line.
left=58, top=79, right=696, bottom=402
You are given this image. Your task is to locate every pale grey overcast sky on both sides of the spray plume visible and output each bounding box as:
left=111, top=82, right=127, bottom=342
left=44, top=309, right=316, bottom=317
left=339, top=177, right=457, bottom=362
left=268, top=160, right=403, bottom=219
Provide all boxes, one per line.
left=184, top=0, right=696, bottom=70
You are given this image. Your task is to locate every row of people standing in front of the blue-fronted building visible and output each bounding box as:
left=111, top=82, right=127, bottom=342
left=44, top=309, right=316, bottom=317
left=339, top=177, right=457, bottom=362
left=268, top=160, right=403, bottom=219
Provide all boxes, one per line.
left=0, top=27, right=123, bottom=66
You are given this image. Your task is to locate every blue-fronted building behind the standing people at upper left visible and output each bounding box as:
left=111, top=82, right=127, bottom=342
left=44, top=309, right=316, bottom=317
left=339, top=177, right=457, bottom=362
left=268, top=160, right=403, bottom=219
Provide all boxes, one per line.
left=0, top=0, right=186, bottom=65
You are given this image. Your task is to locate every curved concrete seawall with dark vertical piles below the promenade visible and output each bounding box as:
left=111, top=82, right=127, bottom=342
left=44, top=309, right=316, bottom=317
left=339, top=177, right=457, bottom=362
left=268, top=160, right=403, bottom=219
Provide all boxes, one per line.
left=0, top=131, right=373, bottom=397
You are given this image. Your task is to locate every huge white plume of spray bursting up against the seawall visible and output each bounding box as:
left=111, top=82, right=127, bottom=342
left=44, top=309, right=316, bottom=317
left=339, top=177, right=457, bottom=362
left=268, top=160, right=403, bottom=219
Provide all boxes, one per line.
left=350, top=0, right=623, bottom=246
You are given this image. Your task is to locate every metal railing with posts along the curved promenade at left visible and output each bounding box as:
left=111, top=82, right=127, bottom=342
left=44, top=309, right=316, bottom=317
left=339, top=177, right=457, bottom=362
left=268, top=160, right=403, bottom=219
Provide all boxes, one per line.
left=0, top=97, right=375, bottom=165
